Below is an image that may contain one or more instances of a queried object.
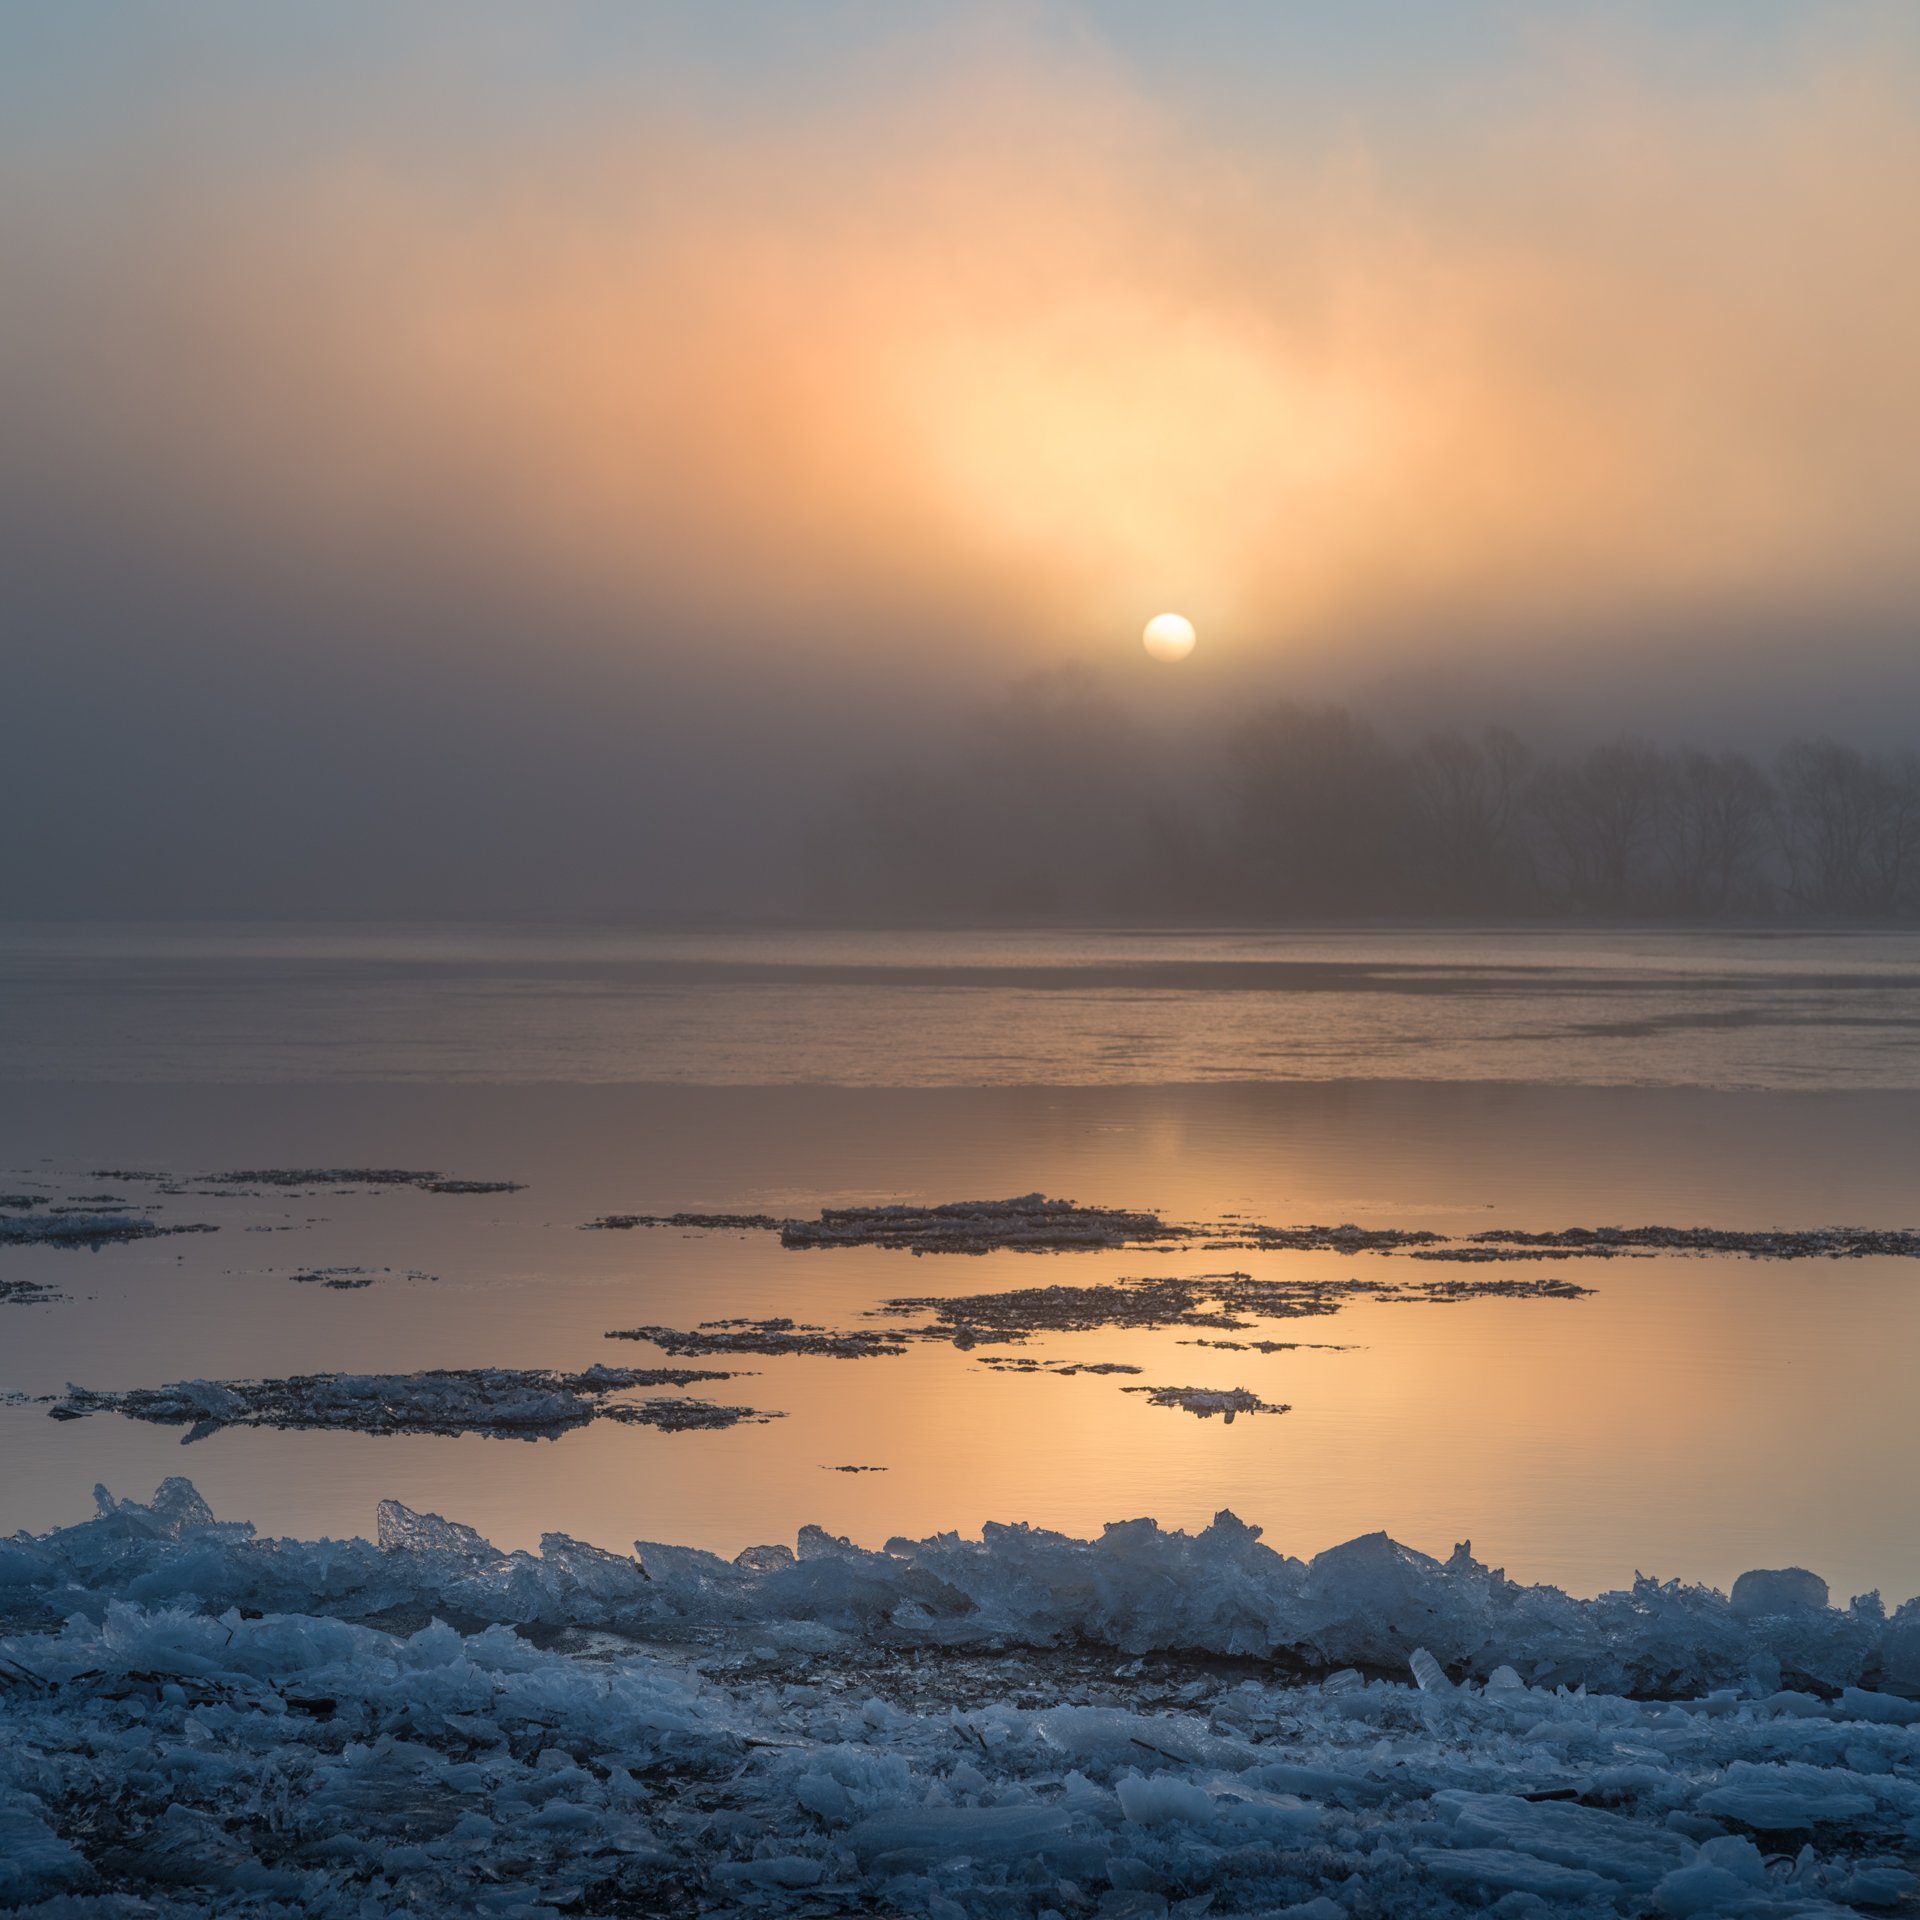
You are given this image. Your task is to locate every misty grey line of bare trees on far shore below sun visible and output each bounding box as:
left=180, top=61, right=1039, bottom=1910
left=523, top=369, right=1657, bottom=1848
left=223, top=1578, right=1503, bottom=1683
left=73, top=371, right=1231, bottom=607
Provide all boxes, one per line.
left=812, top=674, right=1920, bottom=924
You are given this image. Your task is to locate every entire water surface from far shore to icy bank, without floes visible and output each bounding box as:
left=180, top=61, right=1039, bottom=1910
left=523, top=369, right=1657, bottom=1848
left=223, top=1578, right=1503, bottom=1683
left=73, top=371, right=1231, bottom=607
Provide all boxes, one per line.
left=0, top=929, right=1920, bottom=1599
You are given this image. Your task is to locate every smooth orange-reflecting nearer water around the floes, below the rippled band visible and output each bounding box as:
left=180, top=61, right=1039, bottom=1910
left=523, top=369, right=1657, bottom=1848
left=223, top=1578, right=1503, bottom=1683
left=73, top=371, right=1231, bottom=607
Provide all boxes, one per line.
left=0, top=1052, right=1920, bottom=1597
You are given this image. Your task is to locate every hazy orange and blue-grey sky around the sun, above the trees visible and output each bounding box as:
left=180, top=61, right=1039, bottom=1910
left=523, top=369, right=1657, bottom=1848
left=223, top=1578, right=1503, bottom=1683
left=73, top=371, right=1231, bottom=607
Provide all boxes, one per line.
left=0, top=0, right=1920, bottom=914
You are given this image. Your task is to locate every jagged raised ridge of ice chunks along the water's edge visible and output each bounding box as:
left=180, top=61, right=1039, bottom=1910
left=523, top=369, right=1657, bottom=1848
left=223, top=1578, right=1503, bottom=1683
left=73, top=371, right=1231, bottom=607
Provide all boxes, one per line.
left=0, top=1478, right=1920, bottom=1720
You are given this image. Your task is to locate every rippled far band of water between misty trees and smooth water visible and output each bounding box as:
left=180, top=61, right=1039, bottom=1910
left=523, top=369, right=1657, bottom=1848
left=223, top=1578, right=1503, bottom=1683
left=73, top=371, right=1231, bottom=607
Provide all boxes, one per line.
left=11, top=927, right=1920, bottom=1091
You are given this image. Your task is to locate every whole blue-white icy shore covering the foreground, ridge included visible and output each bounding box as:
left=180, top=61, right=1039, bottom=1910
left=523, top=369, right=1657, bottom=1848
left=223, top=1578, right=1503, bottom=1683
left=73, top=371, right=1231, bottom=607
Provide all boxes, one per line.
left=0, top=1480, right=1920, bottom=1920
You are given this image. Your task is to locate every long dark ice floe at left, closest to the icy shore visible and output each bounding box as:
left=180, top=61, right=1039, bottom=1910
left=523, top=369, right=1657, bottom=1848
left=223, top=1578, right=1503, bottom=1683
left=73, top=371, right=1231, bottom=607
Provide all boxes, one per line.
left=48, top=1367, right=778, bottom=1444
